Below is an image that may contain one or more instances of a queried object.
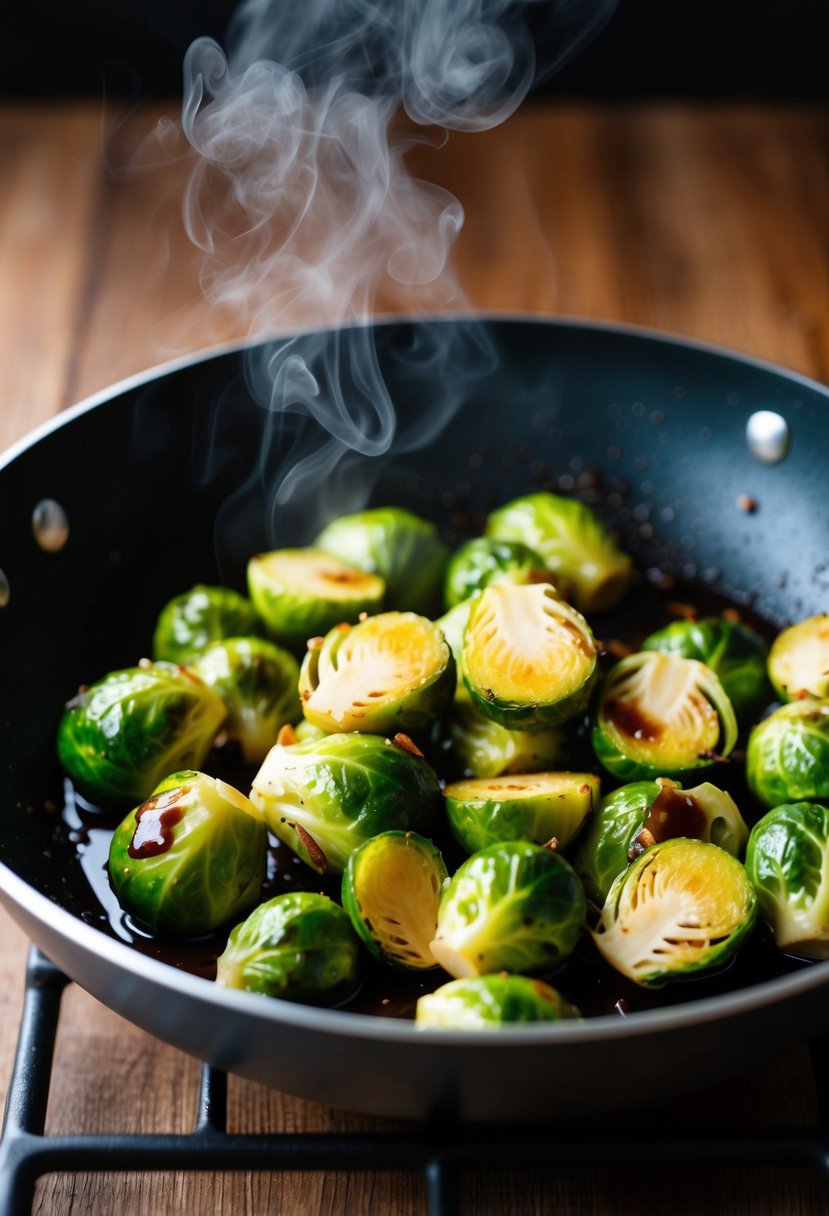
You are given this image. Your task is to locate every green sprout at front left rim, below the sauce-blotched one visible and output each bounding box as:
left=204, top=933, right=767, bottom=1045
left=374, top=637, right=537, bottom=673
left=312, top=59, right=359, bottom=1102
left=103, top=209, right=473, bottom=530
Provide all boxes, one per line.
left=216, top=891, right=360, bottom=1004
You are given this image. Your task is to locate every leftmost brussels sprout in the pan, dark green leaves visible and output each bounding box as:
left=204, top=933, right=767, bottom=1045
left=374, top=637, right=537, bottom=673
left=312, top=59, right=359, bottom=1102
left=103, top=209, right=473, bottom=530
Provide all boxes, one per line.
left=57, top=663, right=226, bottom=804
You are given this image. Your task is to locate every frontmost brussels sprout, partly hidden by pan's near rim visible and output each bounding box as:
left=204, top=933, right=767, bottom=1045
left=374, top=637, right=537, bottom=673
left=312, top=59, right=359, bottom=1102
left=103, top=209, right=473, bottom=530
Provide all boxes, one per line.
left=415, top=974, right=581, bottom=1030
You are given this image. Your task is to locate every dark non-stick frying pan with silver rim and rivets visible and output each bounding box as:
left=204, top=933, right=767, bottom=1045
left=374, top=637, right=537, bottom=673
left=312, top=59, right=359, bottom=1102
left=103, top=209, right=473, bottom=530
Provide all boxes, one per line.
left=0, top=317, right=829, bottom=1120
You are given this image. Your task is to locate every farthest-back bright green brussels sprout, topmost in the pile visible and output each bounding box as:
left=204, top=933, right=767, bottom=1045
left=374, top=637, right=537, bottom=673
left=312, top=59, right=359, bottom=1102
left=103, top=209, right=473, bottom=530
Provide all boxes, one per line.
left=486, top=491, right=633, bottom=613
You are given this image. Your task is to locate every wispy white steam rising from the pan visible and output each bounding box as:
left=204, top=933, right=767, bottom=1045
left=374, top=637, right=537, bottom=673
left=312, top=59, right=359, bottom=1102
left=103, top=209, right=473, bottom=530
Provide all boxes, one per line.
left=182, top=0, right=615, bottom=541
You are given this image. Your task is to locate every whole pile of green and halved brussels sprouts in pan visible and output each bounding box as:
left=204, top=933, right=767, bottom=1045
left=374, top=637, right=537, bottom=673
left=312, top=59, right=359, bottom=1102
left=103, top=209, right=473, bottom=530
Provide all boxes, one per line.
left=53, top=492, right=829, bottom=1029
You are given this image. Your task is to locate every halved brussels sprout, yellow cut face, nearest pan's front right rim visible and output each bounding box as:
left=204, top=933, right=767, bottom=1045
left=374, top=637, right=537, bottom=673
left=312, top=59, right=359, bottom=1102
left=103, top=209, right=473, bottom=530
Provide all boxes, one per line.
left=593, top=837, right=756, bottom=987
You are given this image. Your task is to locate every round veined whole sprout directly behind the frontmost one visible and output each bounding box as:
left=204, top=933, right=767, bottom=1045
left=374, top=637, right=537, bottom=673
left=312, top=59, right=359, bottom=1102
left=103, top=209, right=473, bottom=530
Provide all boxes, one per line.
left=432, top=840, right=587, bottom=979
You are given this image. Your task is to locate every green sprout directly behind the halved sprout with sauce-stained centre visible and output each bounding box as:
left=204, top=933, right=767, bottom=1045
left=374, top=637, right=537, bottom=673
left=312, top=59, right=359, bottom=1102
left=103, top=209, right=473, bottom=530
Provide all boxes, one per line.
left=642, top=617, right=771, bottom=719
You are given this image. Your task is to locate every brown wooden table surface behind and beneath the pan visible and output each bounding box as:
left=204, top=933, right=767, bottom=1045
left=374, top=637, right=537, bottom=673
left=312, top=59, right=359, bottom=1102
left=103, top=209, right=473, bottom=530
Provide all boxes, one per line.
left=0, top=103, right=829, bottom=1216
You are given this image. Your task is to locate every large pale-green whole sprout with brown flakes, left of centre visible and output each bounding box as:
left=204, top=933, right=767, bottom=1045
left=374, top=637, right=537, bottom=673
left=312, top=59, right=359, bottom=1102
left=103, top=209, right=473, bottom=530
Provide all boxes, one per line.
left=250, top=734, right=442, bottom=873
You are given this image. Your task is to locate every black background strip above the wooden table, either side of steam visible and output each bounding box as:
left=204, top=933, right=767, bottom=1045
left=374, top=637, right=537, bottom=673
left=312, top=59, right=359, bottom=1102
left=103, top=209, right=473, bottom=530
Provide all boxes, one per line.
left=6, top=0, right=829, bottom=100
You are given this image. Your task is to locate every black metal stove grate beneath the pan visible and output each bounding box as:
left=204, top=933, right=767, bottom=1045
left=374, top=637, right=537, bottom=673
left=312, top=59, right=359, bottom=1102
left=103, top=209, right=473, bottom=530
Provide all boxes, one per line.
left=0, top=947, right=829, bottom=1216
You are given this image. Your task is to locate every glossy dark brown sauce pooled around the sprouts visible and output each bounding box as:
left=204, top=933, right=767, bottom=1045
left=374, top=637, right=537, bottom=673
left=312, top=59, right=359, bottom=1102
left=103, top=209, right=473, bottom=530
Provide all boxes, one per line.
left=62, top=579, right=812, bottom=1018
